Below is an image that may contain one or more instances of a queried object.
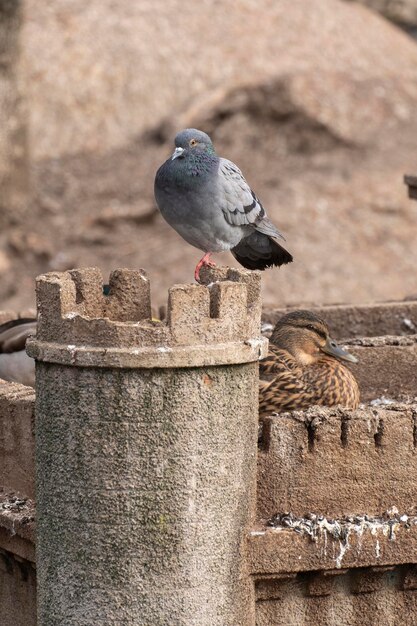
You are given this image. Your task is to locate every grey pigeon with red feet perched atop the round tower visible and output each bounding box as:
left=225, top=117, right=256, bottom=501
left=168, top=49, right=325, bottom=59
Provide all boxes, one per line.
left=155, top=128, right=293, bottom=282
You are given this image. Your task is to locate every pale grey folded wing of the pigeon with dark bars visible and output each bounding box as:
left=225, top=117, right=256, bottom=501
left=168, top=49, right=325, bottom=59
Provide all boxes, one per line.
left=218, top=159, right=284, bottom=239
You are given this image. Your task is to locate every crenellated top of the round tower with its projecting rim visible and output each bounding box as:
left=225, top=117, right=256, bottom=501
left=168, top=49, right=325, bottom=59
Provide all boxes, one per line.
left=28, top=268, right=267, bottom=368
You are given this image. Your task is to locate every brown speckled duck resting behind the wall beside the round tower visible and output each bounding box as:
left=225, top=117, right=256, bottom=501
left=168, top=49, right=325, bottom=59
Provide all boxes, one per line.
left=259, top=310, right=360, bottom=417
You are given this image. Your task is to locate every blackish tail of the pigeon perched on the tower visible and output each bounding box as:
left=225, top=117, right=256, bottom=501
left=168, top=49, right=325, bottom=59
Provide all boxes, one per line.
left=231, top=231, right=293, bottom=270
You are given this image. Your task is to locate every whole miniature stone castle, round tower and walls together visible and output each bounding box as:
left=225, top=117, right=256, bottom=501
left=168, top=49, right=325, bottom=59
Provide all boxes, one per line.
left=0, top=268, right=417, bottom=626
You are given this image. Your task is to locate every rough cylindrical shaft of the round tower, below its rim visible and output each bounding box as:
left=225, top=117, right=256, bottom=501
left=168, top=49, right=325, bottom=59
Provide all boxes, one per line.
left=37, top=364, right=257, bottom=626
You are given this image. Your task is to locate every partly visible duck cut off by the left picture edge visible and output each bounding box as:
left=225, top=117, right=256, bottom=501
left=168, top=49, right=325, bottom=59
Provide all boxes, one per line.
left=0, top=317, right=36, bottom=387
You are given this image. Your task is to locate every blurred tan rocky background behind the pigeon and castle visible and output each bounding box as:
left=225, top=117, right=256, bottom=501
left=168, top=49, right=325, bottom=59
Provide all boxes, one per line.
left=0, top=0, right=417, bottom=309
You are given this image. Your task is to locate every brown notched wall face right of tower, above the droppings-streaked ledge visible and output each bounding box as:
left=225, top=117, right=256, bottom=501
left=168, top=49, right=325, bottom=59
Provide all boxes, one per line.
left=258, top=404, right=417, bottom=519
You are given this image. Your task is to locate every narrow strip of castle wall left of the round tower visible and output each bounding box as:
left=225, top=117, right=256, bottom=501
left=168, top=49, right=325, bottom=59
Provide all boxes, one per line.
left=0, top=383, right=36, bottom=626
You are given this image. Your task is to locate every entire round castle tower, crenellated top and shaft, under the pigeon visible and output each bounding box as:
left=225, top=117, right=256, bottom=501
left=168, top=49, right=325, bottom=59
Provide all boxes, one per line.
left=28, top=269, right=266, bottom=626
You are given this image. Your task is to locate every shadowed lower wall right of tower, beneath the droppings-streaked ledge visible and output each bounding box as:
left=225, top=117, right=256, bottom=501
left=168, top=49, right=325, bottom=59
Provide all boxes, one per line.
left=252, top=566, right=417, bottom=626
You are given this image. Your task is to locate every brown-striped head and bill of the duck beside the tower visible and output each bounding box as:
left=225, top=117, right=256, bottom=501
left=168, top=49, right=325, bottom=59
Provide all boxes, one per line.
left=270, top=311, right=358, bottom=365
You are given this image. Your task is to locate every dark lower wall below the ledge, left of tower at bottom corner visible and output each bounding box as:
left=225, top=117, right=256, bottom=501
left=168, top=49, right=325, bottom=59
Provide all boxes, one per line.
left=0, top=549, right=36, bottom=626
